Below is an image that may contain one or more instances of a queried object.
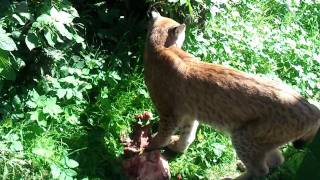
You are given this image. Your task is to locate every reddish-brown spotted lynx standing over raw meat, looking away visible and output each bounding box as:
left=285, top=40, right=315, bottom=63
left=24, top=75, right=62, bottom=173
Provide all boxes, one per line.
left=144, top=12, right=320, bottom=179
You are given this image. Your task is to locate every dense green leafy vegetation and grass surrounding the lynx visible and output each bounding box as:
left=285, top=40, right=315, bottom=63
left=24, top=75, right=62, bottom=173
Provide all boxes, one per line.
left=0, top=0, right=320, bottom=179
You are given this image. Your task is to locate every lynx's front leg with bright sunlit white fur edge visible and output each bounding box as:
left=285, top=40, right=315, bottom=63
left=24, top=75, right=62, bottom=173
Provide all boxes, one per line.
left=168, top=118, right=199, bottom=152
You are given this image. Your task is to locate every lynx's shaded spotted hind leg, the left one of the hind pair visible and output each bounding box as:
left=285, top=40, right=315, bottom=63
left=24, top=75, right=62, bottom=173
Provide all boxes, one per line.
left=232, top=129, right=270, bottom=180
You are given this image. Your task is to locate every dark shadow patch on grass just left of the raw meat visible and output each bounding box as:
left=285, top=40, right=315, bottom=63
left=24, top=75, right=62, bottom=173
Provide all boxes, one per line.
left=69, top=126, right=125, bottom=180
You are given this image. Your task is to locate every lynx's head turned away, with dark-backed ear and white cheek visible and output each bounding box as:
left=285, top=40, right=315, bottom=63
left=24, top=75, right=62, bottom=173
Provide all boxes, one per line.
left=147, top=11, right=186, bottom=48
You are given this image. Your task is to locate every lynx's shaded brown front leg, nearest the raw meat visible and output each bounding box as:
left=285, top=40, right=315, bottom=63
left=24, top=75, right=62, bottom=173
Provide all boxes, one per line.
left=147, top=116, right=177, bottom=150
